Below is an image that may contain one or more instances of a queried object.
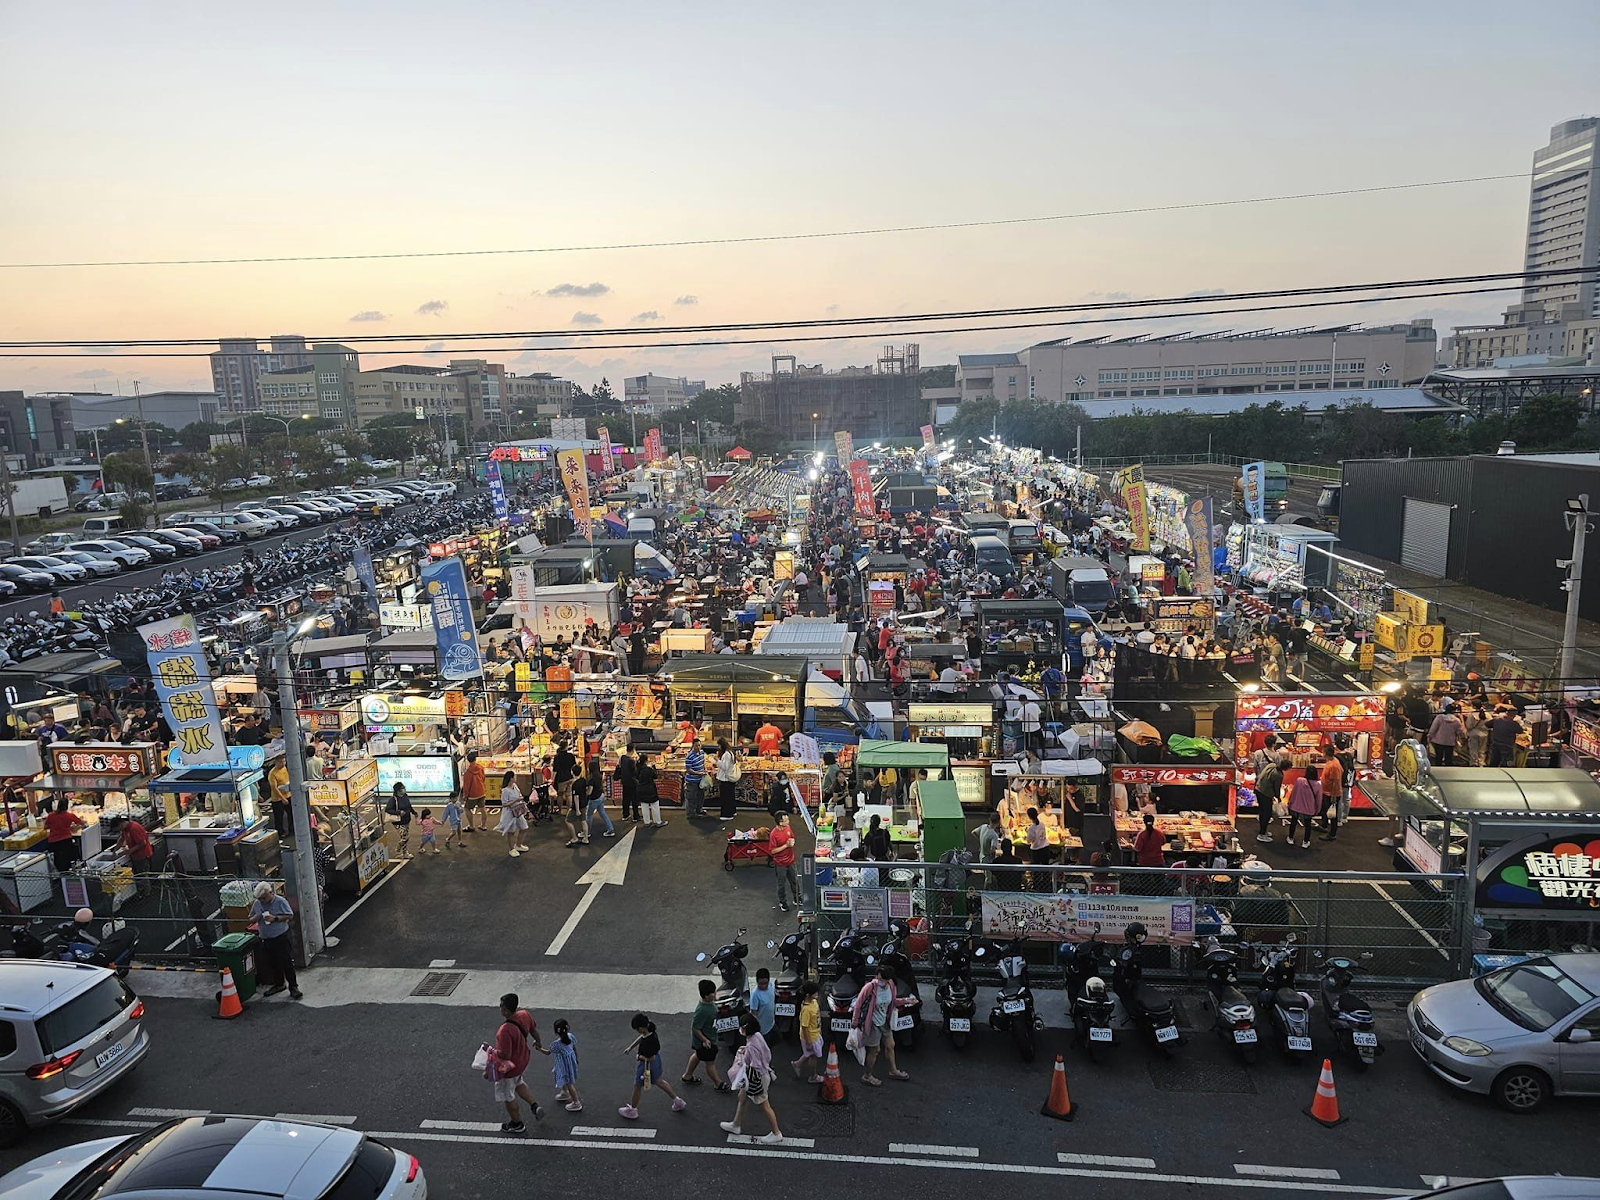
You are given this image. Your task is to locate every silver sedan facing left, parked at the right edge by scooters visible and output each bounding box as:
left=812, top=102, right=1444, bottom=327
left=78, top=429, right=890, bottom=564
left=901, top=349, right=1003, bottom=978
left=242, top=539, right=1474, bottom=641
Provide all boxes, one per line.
left=1406, top=954, right=1600, bottom=1114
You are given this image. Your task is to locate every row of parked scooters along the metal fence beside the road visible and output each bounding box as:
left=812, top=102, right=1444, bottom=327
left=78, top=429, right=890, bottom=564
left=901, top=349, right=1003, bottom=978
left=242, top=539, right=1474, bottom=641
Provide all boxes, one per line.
left=699, top=922, right=1382, bottom=1070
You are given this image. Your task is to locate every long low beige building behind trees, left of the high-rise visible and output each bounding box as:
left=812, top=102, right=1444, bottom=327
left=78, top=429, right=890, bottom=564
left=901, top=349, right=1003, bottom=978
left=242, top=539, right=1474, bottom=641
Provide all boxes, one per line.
left=955, top=320, right=1437, bottom=408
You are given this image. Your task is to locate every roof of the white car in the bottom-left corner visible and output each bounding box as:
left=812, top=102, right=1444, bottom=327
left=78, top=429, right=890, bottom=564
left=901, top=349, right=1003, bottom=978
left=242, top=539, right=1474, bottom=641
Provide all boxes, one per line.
left=96, top=1117, right=363, bottom=1200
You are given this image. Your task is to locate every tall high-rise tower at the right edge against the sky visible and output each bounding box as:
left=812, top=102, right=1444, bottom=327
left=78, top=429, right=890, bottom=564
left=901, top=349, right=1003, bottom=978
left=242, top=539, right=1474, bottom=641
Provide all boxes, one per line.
left=1522, top=117, right=1600, bottom=317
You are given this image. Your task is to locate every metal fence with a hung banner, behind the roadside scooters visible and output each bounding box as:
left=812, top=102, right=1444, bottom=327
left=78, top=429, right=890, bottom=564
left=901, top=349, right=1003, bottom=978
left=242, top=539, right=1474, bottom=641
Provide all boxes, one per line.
left=806, top=862, right=1470, bottom=989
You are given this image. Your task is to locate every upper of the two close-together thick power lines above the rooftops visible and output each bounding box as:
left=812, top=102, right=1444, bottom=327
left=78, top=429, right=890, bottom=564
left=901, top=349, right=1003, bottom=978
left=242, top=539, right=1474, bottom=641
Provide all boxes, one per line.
left=0, top=267, right=1600, bottom=355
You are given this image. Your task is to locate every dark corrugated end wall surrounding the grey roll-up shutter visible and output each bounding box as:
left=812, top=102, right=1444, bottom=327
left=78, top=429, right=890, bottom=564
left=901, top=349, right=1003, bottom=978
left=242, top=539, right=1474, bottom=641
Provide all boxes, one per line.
left=1339, top=458, right=1474, bottom=579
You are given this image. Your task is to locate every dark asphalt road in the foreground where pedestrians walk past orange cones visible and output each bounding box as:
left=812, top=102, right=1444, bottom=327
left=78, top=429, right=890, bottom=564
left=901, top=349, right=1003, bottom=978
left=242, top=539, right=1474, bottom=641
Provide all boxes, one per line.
left=15, top=992, right=1600, bottom=1200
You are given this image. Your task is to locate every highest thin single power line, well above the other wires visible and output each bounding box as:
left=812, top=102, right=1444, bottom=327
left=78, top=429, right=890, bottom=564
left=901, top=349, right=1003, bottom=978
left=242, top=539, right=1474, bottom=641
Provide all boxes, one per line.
left=0, top=171, right=1531, bottom=270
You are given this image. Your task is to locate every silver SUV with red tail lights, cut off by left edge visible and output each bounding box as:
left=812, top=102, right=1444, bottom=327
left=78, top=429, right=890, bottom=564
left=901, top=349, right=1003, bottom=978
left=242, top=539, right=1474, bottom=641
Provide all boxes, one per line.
left=0, top=958, right=150, bottom=1144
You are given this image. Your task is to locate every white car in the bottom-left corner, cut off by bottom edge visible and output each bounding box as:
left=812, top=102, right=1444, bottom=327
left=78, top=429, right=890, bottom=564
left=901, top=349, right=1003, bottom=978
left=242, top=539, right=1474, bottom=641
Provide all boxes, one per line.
left=0, top=1117, right=427, bottom=1200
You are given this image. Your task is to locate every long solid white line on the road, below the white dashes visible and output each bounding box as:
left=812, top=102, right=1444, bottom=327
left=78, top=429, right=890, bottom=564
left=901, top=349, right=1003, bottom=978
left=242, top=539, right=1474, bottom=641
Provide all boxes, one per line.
left=366, top=1130, right=1416, bottom=1198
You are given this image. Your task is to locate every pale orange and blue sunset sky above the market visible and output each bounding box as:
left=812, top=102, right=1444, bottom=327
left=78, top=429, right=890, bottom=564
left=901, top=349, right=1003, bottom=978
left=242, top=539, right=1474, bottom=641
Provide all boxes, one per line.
left=0, top=0, right=1600, bottom=400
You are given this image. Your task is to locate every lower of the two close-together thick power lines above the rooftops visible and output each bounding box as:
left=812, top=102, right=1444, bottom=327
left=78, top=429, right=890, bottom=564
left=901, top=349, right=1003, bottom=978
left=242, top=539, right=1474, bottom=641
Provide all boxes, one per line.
left=0, top=283, right=1574, bottom=360
